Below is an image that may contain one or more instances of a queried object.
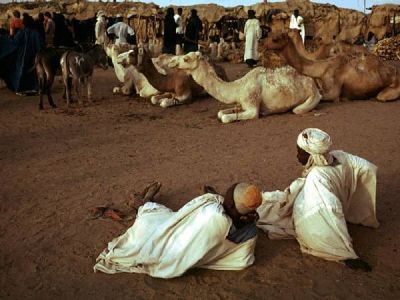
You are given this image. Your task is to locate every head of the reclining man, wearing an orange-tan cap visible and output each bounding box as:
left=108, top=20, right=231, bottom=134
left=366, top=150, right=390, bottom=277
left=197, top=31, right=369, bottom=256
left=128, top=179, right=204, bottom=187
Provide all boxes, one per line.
left=224, top=183, right=262, bottom=227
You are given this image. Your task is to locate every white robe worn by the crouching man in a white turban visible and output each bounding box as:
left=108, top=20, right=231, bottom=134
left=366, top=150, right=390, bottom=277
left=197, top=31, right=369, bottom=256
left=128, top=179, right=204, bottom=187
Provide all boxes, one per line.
left=257, top=151, right=379, bottom=261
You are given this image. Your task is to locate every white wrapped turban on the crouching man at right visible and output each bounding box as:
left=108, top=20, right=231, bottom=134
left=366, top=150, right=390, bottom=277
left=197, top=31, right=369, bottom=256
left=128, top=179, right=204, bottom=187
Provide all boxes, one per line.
left=297, top=128, right=333, bottom=176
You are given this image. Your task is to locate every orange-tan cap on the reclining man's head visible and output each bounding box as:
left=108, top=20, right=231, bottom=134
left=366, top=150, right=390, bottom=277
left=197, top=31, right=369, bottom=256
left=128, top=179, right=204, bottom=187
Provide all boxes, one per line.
left=233, top=183, right=262, bottom=215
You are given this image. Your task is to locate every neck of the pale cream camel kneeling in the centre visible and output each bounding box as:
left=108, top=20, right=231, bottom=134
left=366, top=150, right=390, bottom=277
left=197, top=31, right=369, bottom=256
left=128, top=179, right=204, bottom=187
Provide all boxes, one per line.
left=191, top=60, right=243, bottom=104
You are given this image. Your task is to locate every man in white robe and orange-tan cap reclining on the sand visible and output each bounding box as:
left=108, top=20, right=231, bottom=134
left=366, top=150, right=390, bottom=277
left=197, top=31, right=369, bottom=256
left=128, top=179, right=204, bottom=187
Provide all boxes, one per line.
left=94, top=182, right=261, bottom=278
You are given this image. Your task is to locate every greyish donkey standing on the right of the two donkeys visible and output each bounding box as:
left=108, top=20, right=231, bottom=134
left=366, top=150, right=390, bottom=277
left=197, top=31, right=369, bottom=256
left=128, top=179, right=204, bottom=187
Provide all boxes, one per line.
left=60, top=45, right=108, bottom=106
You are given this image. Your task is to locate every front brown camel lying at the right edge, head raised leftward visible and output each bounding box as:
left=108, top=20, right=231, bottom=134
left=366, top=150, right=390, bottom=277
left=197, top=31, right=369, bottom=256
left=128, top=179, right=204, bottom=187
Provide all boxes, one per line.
left=264, top=34, right=400, bottom=102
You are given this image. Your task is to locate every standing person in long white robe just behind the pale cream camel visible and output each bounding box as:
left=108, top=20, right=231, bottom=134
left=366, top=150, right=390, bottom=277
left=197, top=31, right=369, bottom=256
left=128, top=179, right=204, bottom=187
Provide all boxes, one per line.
left=244, top=9, right=262, bottom=68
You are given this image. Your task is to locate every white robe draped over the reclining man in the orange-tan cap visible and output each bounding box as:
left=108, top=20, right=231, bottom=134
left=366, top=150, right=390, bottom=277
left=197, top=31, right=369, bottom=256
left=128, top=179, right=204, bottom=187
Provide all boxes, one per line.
left=94, top=194, right=256, bottom=278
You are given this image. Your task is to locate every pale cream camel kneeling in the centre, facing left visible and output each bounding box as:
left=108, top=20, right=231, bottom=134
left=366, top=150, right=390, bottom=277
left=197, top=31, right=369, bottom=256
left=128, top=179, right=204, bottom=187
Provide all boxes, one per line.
left=169, top=52, right=321, bottom=123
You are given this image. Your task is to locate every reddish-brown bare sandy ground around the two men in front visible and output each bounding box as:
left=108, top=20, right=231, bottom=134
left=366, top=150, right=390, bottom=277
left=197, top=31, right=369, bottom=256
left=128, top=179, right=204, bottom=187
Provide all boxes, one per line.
left=0, top=64, right=400, bottom=299
